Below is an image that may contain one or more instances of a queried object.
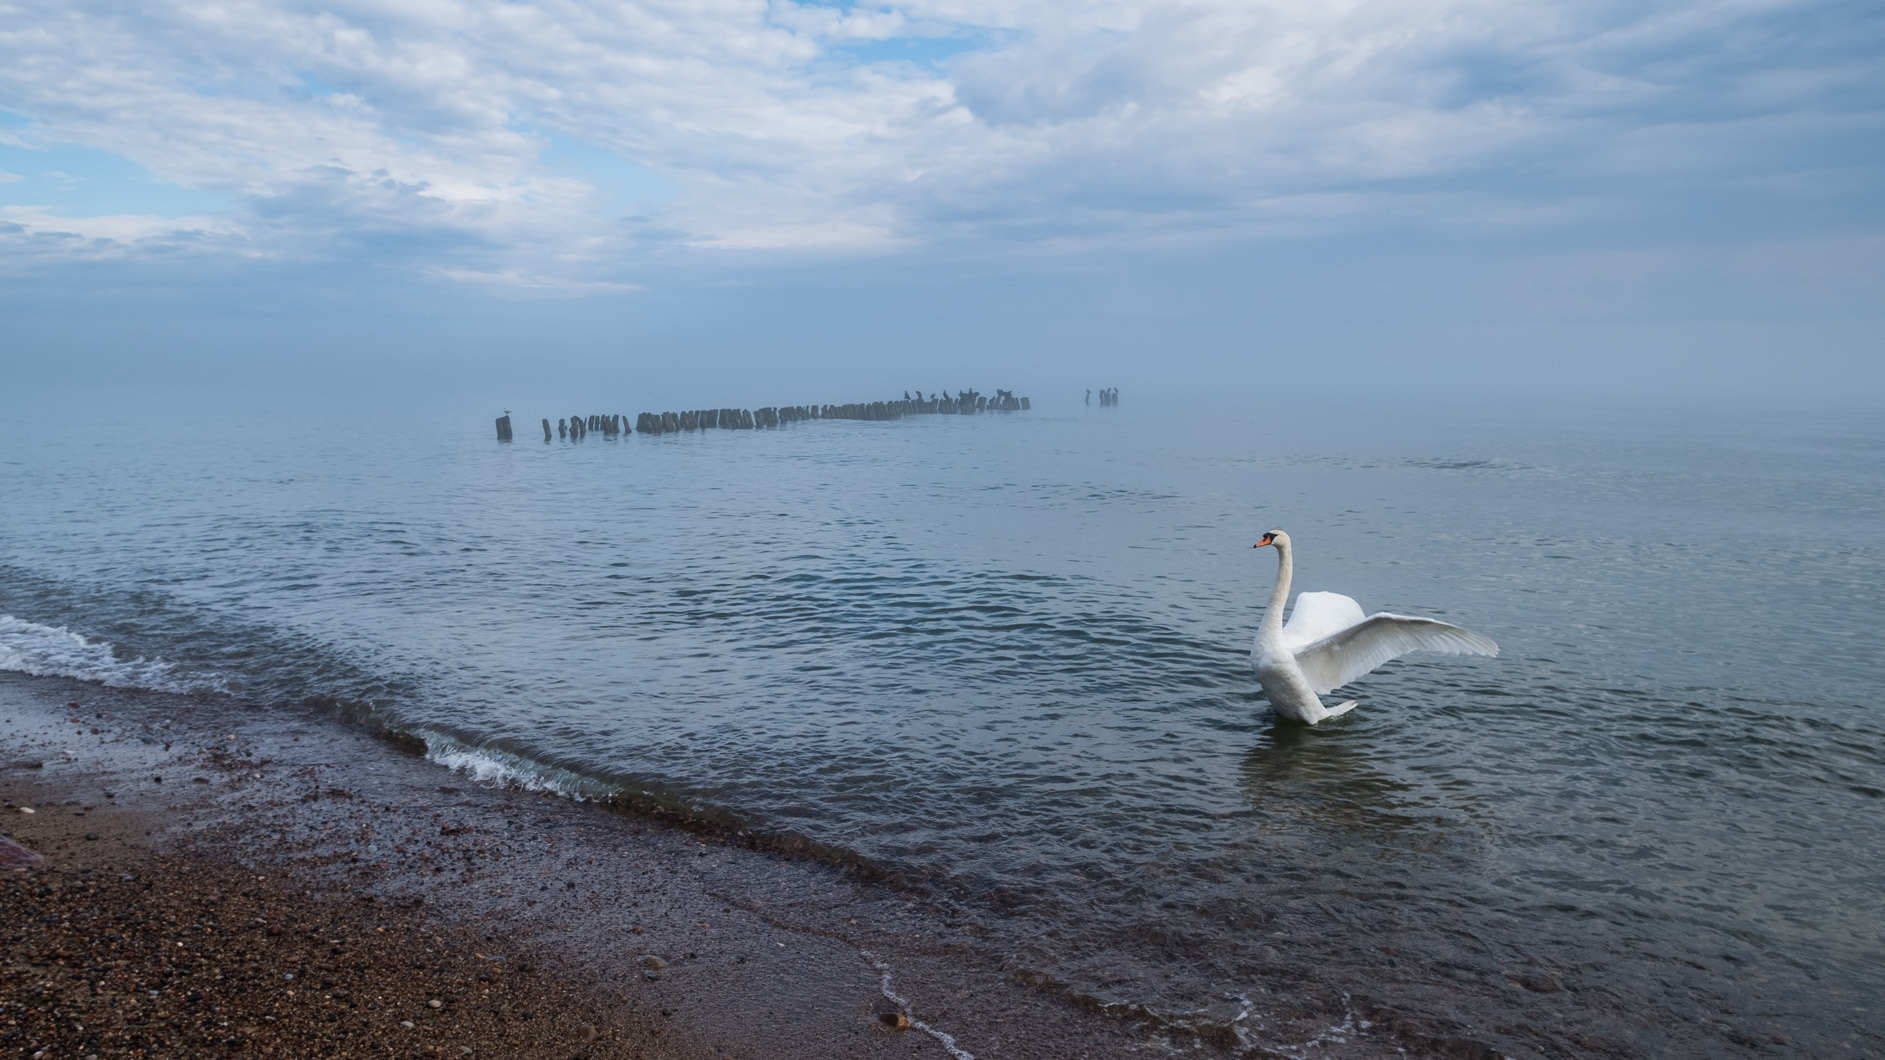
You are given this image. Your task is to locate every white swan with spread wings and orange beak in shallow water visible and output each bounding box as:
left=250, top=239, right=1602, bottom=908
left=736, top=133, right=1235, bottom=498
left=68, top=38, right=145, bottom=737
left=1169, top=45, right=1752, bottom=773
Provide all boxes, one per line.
left=1250, top=530, right=1499, bottom=724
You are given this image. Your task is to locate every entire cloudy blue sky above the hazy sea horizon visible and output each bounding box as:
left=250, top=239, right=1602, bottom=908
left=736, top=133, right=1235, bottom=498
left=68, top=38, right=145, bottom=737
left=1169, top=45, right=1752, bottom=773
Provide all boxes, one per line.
left=0, top=0, right=1885, bottom=407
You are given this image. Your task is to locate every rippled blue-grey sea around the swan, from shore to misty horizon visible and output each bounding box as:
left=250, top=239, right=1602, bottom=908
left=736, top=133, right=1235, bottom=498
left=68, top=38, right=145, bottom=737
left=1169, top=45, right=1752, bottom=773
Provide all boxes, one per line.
left=0, top=394, right=1885, bottom=1056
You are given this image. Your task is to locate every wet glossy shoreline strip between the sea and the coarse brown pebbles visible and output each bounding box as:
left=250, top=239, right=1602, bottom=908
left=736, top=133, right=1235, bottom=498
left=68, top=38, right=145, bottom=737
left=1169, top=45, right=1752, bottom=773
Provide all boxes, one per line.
left=0, top=673, right=1406, bottom=1060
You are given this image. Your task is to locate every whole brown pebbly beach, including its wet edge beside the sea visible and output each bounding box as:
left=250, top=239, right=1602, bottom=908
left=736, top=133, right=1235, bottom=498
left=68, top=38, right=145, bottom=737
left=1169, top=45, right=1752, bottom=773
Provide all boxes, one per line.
left=0, top=673, right=1425, bottom=1060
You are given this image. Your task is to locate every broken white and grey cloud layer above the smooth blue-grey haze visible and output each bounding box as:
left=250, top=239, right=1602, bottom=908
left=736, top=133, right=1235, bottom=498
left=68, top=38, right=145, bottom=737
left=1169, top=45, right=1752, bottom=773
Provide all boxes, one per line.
left=0, top=0, right=1885, bottom=285
